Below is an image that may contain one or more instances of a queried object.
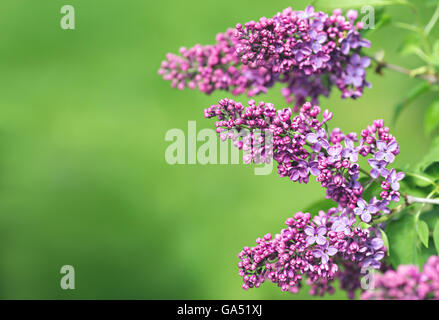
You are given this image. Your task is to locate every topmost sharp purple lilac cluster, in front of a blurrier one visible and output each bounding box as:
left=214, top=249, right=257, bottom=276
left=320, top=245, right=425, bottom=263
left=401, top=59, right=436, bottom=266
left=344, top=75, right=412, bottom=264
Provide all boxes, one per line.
left=236, top=6, right=370, bottom=103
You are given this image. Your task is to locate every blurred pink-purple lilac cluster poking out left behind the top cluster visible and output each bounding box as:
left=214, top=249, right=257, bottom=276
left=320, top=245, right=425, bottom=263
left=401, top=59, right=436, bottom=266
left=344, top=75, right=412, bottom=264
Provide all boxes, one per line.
left=159, top=29, right=275, bottom=96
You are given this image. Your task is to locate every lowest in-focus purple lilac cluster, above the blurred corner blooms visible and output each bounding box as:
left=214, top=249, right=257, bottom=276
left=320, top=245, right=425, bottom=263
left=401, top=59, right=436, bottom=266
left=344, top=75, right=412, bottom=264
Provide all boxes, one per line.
left=238, top=208, right=386, bottom=295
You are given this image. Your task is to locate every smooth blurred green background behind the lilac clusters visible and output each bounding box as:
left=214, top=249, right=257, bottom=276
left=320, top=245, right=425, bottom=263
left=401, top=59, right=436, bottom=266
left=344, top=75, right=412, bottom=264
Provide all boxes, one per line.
left=0, top=0, right=437, bottom=299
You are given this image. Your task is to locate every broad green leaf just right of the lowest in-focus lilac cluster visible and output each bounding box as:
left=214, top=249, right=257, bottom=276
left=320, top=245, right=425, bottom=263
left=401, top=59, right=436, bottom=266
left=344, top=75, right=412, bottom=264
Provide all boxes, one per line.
left=386, top=210, right=417, bottom=268
